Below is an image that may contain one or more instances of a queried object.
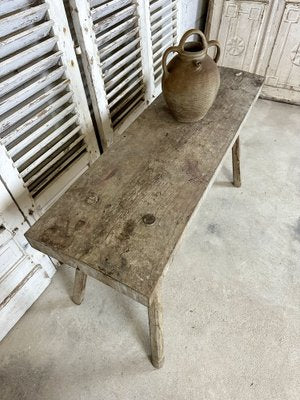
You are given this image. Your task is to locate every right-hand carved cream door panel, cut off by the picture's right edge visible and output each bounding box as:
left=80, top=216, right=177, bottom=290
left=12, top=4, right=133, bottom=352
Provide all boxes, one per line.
left=263, top=1, right=300, bottom=104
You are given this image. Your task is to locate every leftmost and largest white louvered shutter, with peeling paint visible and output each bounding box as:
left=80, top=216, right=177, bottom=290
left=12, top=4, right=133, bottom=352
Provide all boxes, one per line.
left=0, top=0, right=99, bottom=222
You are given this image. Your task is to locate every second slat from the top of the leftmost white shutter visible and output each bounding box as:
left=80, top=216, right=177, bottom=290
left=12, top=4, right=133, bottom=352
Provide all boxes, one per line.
left=0, top=21, right=53, bottom=58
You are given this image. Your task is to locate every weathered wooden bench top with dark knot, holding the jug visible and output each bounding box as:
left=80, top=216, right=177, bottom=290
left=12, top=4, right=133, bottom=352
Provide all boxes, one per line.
left=26, top=68, right=262, bottom=305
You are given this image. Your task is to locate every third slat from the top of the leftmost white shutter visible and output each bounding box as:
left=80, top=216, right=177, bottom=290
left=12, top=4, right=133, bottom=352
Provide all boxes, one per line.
left=0, top=36, right=57, bottom=77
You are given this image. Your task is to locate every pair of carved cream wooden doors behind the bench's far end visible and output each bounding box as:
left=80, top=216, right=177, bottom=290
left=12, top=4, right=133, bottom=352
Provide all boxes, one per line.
left=206, top=0, right=300, bottom=104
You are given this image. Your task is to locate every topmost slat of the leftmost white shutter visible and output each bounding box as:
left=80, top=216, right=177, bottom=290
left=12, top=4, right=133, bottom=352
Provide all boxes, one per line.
left=0, top=3, right=49, bottom=37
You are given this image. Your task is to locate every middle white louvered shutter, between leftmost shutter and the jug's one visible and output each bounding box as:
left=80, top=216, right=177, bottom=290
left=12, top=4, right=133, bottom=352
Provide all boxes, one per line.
left=70, top=0, right=149, bottom=148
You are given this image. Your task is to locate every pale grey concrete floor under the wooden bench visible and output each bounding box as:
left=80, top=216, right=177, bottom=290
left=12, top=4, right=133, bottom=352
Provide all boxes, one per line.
left=0, top=100, right=300, bottom=400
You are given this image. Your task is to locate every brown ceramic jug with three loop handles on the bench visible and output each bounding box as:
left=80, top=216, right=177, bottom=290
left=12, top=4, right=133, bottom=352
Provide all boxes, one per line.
left=162, top=29, right=220, bottom=122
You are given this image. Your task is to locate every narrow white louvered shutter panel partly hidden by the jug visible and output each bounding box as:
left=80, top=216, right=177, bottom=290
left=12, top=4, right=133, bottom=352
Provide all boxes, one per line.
left=149, top=0, right=178, bottom=96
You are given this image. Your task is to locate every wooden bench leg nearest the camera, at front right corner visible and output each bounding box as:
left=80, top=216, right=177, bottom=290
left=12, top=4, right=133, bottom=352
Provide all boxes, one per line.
left=148, top=287, right=164, bottom=368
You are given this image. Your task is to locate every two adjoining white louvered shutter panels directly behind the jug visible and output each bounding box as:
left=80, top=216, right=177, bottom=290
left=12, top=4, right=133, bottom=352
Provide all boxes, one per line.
left=70, top=0, right=177, bottom=148
